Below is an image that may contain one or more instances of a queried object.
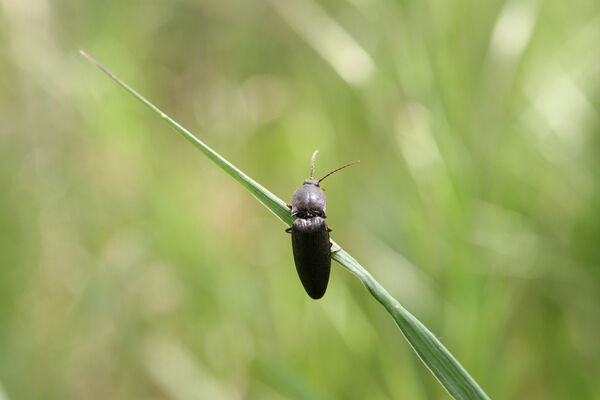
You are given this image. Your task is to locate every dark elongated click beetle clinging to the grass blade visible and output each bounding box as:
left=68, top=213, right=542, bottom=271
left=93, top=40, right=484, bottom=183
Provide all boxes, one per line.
left=285, top=150, right=360, bottom=300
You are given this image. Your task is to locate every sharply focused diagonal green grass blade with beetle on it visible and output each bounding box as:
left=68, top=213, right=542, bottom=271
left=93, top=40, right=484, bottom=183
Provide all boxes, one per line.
left=80, top=50, right=488, bottom=399
